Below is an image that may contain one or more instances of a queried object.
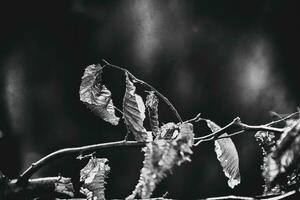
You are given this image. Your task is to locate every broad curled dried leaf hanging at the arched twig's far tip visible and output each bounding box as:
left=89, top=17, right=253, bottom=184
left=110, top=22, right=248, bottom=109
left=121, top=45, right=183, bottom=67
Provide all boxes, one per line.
left=79, top=64, right=120, bottom=125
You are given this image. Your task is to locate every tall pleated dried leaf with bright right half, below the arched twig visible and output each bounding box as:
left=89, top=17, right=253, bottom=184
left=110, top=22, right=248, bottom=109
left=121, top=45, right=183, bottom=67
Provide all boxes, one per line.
left=123, top=73, right=152, bottom=141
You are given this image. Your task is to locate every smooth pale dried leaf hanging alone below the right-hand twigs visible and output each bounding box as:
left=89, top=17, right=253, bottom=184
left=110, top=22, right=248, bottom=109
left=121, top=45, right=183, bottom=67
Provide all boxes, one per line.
left=206, top=120, right=241, bottom=188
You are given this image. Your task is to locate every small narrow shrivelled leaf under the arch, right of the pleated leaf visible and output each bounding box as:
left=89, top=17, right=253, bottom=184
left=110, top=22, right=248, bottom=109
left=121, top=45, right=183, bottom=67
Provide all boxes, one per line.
left=146, top=91, right=159, bottom=136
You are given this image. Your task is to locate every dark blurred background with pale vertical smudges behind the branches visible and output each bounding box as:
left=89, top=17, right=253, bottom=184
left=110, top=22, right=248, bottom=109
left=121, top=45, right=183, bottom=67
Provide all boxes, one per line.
left=0, top=0, right=300, bottom=199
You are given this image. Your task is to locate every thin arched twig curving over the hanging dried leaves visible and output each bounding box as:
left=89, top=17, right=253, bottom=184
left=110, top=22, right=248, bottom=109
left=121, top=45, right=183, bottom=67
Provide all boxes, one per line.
left=102, top=59, right=183, bottom=122
